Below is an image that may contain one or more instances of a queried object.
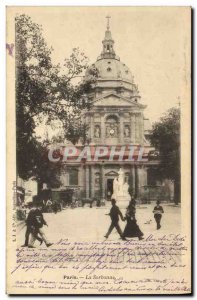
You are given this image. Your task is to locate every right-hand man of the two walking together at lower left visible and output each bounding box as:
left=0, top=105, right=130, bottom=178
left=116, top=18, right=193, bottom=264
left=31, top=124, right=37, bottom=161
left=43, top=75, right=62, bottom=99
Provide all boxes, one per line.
left=29, top=203, right=53, bottom=248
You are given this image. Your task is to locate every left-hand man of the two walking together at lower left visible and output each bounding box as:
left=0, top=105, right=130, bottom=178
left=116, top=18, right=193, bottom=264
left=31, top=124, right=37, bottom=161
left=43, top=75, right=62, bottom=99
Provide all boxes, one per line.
left=21, top=202, right=43, bottom=247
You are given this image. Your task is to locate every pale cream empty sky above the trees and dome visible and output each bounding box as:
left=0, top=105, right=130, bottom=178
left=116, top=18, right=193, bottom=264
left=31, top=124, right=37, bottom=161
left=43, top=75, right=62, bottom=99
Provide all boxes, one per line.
left=9, top=7, right=190, bottom=123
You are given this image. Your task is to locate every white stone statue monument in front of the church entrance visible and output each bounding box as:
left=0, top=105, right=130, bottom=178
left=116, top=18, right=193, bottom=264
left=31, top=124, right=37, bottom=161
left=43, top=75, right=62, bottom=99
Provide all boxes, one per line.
left=112, top=168, right=131, bottom=205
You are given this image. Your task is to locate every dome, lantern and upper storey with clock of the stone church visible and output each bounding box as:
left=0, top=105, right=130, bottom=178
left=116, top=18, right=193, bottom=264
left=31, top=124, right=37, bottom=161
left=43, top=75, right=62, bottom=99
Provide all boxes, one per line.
left=86, top=19, right=146, bottom=145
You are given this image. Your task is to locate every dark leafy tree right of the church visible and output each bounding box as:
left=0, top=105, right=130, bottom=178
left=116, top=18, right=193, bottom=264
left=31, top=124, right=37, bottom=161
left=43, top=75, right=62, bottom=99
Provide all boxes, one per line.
left=150, top=107, right=181, bottom=204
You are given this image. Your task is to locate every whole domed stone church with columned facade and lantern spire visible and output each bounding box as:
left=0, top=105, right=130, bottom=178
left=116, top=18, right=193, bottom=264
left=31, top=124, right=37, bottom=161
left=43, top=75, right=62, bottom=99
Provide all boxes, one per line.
left=57, top=17, right=174, bottom=200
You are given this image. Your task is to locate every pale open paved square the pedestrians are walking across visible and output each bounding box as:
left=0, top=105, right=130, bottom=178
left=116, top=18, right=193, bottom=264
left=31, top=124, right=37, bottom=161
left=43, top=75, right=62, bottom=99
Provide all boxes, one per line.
left=17, top=203, right=181, bottom=247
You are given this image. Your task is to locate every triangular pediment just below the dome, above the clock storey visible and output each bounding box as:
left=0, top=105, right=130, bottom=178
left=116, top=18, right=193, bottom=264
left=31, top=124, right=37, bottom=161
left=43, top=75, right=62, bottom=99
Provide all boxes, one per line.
left=94, top=94, right=145, bottom=108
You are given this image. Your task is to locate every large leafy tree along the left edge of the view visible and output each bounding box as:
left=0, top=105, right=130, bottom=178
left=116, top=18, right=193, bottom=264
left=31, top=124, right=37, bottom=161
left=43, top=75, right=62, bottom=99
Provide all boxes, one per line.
left=15, top=15, right=94, bottom=184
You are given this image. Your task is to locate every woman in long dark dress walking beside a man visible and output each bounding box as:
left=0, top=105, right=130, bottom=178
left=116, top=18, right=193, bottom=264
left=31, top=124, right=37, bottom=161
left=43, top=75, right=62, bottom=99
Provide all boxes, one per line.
left=123, top=200, right=144, bottom=240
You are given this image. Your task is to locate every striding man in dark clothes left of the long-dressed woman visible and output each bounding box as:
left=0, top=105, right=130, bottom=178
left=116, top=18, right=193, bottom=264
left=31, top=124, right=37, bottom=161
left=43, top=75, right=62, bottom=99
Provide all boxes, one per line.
left=104, top=199, right=126, bottom=240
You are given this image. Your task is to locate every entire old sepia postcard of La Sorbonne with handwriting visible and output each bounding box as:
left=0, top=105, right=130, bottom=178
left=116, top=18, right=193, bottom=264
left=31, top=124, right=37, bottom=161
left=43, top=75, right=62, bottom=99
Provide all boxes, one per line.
left=6, top=6, right=192, bottom=295
